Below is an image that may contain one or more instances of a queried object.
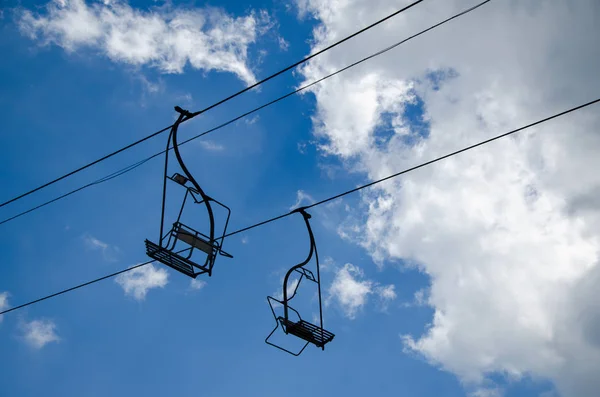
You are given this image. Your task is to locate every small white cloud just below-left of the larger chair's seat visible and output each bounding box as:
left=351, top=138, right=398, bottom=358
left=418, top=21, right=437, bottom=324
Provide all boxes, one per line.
left=115, top=264, right=169, bottom=301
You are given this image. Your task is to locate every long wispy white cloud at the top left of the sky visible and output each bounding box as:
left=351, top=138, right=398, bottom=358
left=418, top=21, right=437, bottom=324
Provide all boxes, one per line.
left=20, top=0, right=270, bottom=84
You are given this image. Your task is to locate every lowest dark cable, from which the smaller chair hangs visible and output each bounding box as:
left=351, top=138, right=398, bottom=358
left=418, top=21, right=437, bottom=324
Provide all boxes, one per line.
left=0, top=98, right=600, bottom=315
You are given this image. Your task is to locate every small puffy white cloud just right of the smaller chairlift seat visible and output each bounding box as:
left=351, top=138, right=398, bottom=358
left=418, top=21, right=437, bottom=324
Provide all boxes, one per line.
left=326, top=263, right=396, bottom=319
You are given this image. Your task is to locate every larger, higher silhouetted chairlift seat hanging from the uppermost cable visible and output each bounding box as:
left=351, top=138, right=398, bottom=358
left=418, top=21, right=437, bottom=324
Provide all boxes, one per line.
left=146, top=107, right=233, bottom=278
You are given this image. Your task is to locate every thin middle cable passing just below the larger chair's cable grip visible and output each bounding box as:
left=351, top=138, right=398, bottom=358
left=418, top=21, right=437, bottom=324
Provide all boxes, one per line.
left=0, top=0, right=492, bottom=225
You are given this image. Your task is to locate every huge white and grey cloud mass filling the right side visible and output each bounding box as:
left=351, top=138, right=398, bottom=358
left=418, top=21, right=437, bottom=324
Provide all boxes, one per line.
left=300, top=0, right=600, bottom=397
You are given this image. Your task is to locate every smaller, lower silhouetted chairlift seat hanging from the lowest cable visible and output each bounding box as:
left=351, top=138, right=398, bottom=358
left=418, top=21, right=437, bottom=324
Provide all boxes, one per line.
left=265, top=208, right=335, bottom=356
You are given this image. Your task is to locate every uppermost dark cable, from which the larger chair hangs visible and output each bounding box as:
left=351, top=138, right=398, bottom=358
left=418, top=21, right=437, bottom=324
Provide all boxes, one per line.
left=0, top=0, right=425, bottom=208
